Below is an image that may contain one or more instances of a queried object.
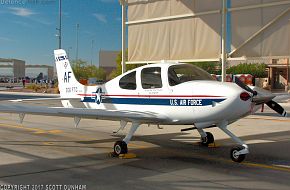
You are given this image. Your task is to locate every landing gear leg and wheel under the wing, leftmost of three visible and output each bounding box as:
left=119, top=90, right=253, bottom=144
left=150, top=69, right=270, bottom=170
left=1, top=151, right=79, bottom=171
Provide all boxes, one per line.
left=114, top=122, right=140, bottom=156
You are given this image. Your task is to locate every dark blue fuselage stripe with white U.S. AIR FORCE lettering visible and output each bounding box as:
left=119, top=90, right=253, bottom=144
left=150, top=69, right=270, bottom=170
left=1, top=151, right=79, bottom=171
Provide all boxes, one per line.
left=82, top=97, right=225, bottom=106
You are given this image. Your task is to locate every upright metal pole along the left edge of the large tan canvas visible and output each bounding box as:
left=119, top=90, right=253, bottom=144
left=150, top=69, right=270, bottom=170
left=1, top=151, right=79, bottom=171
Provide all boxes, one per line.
left=120, top=0, right=126, bottom=73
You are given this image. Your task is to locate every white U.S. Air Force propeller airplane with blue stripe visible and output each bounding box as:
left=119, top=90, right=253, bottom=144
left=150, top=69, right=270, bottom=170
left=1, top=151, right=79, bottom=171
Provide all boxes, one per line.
left=0, top=49, right=287, bottom=162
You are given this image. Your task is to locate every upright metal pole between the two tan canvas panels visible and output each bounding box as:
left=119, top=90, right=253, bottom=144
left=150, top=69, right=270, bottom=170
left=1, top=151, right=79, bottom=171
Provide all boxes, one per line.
left=221, top=0, right=227, bottom=82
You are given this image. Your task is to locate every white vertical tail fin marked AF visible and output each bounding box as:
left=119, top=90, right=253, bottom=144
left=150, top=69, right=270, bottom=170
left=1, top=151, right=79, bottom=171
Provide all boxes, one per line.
left=54, top=49, right=84, bottom=98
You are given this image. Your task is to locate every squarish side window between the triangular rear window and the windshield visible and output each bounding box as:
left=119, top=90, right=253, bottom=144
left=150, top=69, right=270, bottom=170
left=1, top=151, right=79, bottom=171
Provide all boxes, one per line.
left=141, top=67, right=162, bottom=89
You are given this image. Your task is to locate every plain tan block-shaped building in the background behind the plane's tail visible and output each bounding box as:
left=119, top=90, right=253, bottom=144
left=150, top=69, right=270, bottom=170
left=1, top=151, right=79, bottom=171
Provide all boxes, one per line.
left=99, top=50, right=119, bottom=75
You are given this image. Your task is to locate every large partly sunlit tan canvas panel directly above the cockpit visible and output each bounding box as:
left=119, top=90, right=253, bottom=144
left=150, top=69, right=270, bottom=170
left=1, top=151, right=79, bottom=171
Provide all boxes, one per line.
left=128, top=0, right=221, bottom=61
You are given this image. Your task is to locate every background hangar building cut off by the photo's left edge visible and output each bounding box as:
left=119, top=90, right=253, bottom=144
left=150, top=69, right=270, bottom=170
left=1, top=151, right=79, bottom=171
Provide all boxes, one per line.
left=0, top=58, right=25, bottom=82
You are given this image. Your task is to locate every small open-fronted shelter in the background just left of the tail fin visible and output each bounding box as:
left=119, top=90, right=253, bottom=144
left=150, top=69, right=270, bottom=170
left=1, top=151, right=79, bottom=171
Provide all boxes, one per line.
left=25, top=65, right=54, bottom=80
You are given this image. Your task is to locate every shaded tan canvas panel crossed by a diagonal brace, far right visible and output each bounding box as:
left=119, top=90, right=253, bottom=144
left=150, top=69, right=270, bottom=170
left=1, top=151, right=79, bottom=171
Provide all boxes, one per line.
left=231, top=0, right=290, bottom=57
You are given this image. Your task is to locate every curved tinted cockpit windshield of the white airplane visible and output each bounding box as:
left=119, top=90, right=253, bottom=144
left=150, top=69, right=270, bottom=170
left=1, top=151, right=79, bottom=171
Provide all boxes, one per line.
left=168, top=64, right=214, bottom=86
